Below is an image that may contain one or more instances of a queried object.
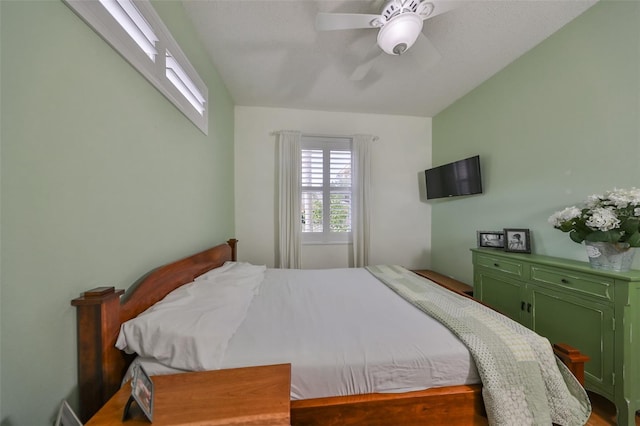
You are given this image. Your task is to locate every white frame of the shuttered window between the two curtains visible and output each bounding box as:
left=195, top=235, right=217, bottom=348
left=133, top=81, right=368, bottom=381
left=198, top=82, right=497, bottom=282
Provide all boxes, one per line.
left=300, top=135, right=354, bottom=245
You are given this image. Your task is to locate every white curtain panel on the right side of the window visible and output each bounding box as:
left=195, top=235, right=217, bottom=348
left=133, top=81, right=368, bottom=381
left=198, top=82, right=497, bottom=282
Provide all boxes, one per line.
left=351, top=135, right=377, bottom=268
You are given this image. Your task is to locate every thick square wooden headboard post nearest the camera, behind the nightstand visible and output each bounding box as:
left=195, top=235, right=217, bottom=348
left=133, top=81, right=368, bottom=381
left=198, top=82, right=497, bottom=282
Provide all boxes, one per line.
left=71, top=287, right=126, bottom=423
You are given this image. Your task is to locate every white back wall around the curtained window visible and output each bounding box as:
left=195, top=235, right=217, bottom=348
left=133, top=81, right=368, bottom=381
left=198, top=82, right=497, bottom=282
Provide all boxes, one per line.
left=235, top=106, right=431, bottom=268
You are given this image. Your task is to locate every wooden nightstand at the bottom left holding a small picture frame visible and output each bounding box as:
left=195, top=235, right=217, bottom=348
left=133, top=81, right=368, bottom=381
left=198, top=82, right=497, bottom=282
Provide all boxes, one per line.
left=86, top=364, right=291, bottom=426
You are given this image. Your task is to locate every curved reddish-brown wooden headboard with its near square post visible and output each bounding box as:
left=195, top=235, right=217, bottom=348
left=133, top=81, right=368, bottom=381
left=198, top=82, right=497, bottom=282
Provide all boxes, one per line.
left=71, top=239, right=237, bottom=422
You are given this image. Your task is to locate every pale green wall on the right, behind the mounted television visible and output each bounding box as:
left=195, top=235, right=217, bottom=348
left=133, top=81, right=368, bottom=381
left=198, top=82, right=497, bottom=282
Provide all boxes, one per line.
left=432, top=0, right=640, bottom=283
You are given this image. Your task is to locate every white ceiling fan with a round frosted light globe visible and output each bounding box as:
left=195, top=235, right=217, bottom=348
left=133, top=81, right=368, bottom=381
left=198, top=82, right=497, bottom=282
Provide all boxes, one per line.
left=316, top=0, right=455, bottom=80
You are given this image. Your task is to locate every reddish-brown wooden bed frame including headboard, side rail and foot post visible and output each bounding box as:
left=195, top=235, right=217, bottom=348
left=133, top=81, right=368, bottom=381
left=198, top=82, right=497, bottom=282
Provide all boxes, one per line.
left=71, top=239, right=588, bottom=426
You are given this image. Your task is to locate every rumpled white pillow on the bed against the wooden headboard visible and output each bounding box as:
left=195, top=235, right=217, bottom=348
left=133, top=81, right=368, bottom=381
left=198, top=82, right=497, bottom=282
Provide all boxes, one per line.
left=116, top=264, right=266, bottom=371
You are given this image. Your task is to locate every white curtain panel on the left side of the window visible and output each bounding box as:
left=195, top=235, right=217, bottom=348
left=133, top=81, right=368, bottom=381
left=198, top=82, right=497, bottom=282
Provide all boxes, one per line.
left=276, top=131, right=302, bottom=269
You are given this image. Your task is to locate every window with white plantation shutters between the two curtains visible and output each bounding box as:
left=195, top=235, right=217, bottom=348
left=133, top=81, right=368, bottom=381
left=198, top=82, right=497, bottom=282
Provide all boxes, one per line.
left=300, top=136, right=351, bottom=243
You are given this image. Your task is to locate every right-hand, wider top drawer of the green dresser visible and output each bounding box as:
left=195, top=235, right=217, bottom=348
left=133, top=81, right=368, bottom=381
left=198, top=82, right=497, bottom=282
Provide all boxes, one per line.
left=531, top=265, right=614, bottom=301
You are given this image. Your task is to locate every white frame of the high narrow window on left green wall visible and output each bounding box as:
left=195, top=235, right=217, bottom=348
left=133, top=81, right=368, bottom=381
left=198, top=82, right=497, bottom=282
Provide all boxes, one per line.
left=63, top=0, right=209, bottom=135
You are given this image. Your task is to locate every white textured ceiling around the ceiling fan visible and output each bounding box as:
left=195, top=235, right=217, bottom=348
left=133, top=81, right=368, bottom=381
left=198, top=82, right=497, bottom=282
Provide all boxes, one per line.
left=183, top=0, right=596, bottom=117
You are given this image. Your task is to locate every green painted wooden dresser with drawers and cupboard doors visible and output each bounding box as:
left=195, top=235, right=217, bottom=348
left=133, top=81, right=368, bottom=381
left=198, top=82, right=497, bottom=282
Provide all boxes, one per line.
left=472, top=249, right=640, bottom=425
